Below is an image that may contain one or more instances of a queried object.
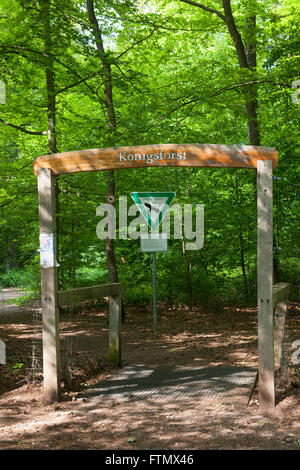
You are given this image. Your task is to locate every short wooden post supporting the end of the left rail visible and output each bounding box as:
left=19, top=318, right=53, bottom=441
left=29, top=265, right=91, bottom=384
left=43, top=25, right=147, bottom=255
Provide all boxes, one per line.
left=108, top=294, right=121, bottom=366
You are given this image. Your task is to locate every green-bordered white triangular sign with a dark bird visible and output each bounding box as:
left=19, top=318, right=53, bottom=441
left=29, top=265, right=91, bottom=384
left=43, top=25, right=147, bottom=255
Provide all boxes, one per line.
left=131, top=192, right=175, bottom=231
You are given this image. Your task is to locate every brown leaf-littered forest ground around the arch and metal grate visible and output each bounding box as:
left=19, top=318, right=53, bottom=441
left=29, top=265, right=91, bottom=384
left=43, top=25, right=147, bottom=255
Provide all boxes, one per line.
left=0, top=302, right=300, bottom=450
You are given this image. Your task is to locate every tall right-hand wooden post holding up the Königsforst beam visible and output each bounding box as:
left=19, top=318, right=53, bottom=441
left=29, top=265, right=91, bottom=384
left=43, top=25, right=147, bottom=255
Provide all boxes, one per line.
left=257, top=160, right=275, bottom=409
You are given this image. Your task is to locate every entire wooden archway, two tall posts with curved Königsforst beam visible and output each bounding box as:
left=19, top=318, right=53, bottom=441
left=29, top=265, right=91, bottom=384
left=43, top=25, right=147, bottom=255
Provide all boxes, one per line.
left=33, top=144, right=278, bottom=408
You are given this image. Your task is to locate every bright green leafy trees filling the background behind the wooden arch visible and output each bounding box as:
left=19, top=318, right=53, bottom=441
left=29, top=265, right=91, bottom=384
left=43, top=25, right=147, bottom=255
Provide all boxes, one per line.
left=0, top=0, right=300, bottom=305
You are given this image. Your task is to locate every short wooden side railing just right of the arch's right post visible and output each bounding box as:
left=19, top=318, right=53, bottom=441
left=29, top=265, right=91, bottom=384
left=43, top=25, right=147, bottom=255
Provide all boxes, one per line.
left=273, top=282, right=290, bottom=370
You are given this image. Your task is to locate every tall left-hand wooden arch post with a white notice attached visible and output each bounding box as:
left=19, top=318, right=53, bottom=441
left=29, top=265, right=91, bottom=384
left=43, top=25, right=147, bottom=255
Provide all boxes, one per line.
left=38, top=168, right=61, bottom=402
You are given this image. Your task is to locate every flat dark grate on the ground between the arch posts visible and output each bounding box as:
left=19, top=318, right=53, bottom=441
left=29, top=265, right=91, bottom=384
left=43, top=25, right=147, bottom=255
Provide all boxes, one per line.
left=81, top=365, right=256, bottom=404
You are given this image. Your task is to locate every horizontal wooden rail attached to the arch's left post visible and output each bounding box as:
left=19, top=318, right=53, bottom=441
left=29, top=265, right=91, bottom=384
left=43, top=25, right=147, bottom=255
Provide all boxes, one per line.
left=57, top=283, right=124, bottom=307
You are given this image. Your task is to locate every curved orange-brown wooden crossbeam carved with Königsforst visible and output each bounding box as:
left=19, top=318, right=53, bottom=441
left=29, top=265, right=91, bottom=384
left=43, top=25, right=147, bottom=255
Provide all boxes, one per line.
left=33, top=144, right=278, bottom=175
